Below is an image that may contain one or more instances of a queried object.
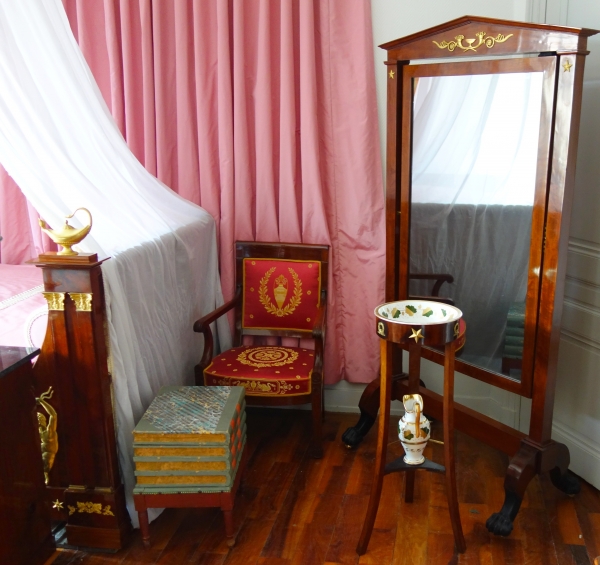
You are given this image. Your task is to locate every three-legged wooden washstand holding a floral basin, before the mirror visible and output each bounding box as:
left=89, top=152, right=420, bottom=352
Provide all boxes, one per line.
left=356, top=300, right=466, bottom=555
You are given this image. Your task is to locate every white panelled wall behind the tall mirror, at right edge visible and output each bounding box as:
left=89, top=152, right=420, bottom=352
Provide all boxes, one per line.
left=546, top=0, right=600, bottom=488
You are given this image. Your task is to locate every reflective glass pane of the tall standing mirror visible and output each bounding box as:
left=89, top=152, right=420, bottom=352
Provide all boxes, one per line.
left=409, top=72, right=543, bottom=380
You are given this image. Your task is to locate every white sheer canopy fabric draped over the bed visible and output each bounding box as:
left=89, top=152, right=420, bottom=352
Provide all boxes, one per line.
left=0, top=0, right=229, bottom=524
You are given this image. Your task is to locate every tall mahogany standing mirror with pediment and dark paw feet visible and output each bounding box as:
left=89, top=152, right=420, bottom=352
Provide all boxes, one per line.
left=343, top=16, right=597, bottom=535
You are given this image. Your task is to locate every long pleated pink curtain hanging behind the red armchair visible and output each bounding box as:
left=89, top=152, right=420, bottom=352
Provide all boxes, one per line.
left=1, top=0, right=385, bottom=383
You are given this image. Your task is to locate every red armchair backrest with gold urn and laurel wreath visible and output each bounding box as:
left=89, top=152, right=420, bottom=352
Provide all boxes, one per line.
left=236, top=241, right=329, bottom=337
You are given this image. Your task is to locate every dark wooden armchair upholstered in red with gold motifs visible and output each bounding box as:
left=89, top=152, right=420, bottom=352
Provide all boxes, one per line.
left=194, top=241, right=329, bottom=458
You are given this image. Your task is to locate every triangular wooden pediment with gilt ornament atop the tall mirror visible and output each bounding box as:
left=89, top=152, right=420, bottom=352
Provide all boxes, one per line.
left=380, top=16, right=596, bottom=61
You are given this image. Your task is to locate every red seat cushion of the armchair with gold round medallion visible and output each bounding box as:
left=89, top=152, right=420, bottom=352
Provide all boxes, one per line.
left=204, top=346, right=315, bottom=396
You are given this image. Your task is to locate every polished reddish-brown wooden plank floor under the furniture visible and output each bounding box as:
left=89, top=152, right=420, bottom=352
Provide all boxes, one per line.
left=48, top=409, right=600, bottom=565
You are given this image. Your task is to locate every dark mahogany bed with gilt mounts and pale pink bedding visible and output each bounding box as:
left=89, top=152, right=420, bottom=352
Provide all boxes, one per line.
left=0, top=255, right=131, bottom=550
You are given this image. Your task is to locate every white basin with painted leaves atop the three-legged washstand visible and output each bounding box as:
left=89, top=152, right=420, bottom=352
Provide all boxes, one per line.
left=375, top=300, right=462, bottom=326
